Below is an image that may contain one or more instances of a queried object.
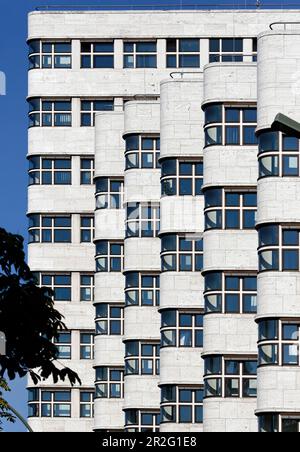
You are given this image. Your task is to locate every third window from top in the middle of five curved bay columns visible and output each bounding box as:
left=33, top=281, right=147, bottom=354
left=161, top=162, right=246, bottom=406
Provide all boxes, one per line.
left=160, top=309, right=203, bottom=347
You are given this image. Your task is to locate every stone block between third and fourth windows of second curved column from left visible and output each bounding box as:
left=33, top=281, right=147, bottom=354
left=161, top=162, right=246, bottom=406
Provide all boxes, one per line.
left=124, top=306, right=160, bottom=341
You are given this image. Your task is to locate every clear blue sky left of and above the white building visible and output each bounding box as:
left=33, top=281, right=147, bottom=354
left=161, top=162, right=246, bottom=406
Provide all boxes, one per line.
left=0, top=0, right=300, bottom=431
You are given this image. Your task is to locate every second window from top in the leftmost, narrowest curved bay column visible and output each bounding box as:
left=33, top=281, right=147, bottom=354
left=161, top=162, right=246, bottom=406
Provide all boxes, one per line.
left=96, top=240, right=124, bottom=273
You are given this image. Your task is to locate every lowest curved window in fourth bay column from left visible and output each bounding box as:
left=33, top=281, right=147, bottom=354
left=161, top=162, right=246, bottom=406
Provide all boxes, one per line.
left=204, top=356, right=257, bottom=398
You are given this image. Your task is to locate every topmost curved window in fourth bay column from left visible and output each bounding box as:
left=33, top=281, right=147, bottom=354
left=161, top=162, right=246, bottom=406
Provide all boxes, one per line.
left=203, top=104, right=257, bottom=146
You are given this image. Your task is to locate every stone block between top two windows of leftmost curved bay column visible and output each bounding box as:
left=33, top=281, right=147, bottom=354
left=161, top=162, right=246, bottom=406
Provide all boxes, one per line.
left=95, top=209, right=125, bottom=240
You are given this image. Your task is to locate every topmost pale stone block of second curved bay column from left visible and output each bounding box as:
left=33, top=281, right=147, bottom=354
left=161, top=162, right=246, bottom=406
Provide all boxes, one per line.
left=123, top=100, right=160, bottom=137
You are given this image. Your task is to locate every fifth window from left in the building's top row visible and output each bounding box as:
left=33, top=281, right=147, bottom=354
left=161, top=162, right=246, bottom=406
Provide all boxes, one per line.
left=209, top=38, right=243, bottom=63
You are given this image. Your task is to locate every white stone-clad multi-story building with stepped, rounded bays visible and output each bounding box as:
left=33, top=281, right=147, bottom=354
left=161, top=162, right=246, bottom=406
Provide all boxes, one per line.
left=28, top=9, right=300, bottom=432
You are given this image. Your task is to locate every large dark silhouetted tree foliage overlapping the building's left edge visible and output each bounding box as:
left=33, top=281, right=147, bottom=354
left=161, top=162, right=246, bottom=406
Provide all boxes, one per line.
left=0, top=228, right=81, bottom=385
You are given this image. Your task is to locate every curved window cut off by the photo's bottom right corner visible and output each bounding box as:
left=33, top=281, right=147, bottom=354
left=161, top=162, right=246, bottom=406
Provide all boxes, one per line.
left=258, top=413, right=300, bottom=433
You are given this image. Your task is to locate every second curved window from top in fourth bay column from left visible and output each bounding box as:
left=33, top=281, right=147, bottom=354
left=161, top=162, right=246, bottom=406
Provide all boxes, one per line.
left=204, top=188, right=257, bottom=230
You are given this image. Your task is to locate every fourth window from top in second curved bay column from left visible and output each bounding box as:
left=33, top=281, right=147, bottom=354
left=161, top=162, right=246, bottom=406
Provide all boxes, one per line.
left=125, top=341, right=160, bottom=375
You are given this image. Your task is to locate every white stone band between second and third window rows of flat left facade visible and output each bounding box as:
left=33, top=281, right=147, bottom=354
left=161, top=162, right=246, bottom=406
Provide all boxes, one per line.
left=28, top=126, right=95, bottom=156
